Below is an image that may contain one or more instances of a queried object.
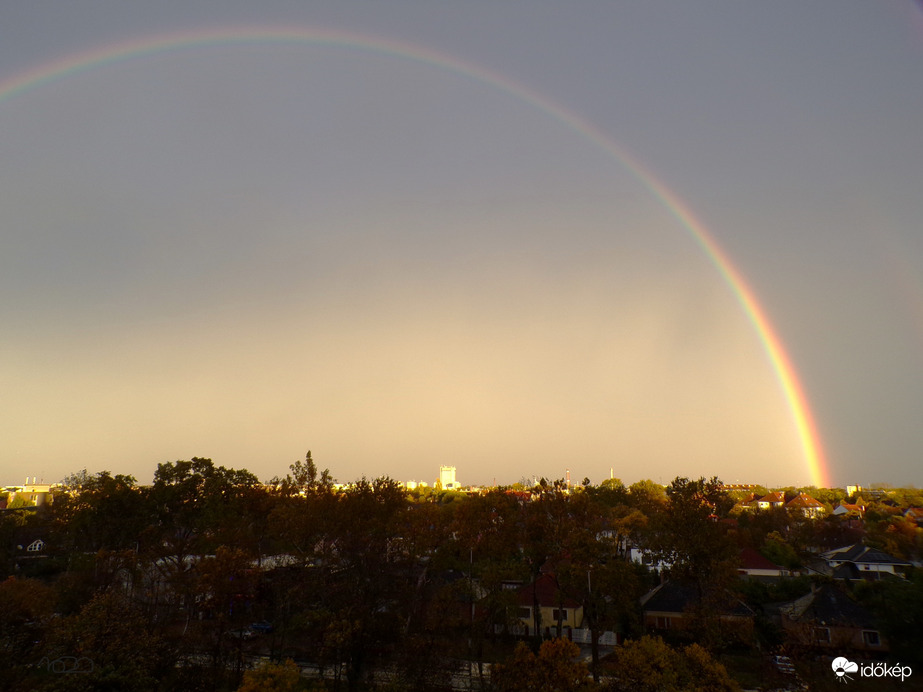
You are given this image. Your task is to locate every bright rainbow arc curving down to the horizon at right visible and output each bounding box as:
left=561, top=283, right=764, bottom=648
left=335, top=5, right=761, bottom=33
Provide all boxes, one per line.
left=0, top=27, right=829, bottom=487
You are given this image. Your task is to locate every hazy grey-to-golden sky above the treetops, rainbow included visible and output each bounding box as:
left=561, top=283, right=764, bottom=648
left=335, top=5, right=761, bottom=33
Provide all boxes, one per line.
left=0, top=0, right=923, bottom=486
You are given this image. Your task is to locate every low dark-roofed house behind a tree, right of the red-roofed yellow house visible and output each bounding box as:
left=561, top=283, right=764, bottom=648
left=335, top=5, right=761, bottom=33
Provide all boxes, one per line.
left=641, top=581, right=756, bottom=637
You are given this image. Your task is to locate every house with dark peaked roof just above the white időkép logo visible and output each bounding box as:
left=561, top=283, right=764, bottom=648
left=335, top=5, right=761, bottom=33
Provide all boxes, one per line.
left=779, top=584, right=888, bottom=656
